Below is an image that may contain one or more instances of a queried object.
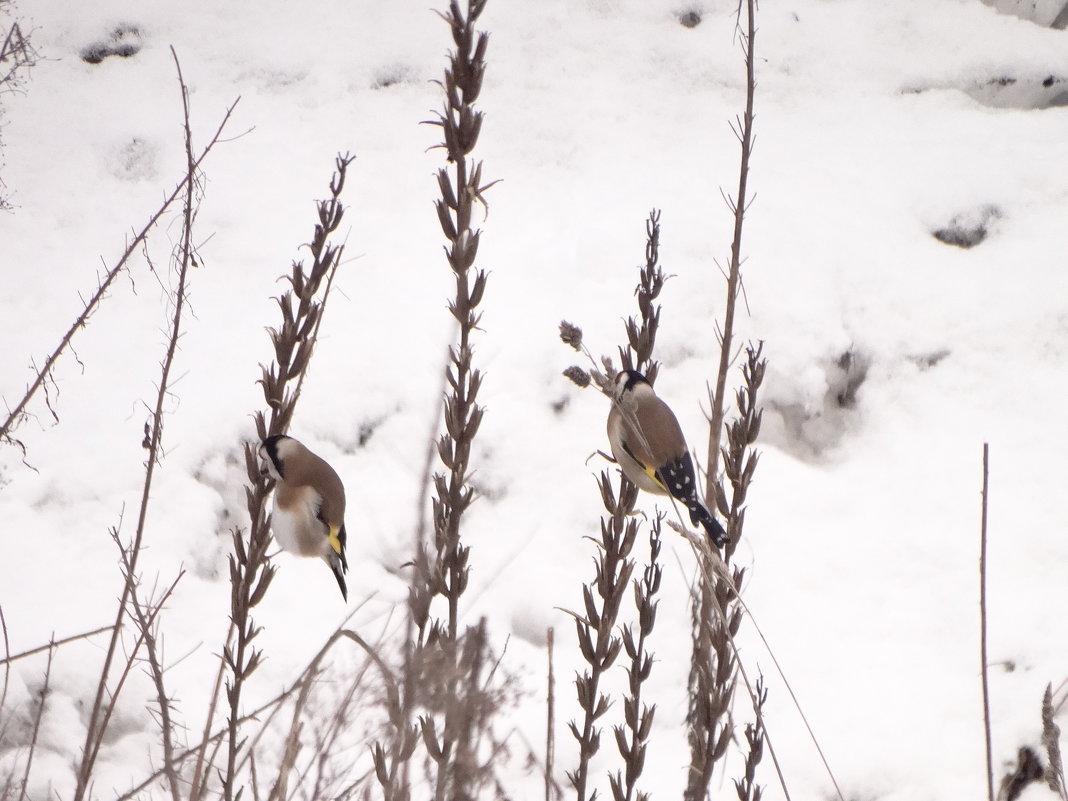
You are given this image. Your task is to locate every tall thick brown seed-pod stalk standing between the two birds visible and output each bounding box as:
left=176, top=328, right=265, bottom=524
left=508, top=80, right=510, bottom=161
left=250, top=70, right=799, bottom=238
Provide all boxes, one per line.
left=373, top=0, right=492, bottom=801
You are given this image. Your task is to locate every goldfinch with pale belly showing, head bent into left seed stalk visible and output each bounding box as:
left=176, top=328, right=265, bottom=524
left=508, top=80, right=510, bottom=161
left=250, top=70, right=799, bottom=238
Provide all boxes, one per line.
left=260, top=435, right=348, bottom=601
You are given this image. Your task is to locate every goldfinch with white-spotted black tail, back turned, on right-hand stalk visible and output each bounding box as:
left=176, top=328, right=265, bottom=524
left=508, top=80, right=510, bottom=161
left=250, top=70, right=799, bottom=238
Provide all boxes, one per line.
left=608, top=370, right=727, bottom=548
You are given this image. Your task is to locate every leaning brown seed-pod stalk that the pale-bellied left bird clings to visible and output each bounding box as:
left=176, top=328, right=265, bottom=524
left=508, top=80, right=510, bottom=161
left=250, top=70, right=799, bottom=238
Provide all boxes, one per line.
left=221, top=155, right=352, bottom=801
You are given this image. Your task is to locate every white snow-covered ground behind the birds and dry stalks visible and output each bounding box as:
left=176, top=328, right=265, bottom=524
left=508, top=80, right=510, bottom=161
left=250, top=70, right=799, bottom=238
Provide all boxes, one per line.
left=0, top=0, right=1068, bottom=799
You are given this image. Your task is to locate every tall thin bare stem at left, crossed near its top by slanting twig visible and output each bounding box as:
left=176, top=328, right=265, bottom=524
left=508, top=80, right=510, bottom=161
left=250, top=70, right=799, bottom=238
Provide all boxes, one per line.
left=74, top=48, right=207, bottom=801
